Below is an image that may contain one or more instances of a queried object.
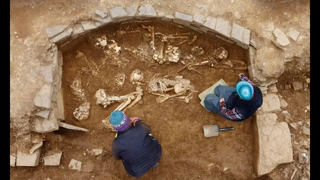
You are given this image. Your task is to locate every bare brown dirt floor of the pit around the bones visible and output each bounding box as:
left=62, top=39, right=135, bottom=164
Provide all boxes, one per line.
left=13, top=22, right=254, bottom=180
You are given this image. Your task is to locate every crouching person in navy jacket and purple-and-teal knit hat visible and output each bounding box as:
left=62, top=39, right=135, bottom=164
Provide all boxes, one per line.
left=110, top=110, right=162, bottom=177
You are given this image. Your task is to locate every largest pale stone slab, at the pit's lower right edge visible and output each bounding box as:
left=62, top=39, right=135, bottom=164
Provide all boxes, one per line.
left=254, top=113, right=293, bottom=176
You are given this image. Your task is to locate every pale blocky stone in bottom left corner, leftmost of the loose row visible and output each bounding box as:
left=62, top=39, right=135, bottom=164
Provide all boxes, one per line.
left=16, top=149, right=41, bottom=166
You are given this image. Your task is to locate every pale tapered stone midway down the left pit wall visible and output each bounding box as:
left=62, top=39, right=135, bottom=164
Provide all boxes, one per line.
left=34, top=84, right=53, bottom=109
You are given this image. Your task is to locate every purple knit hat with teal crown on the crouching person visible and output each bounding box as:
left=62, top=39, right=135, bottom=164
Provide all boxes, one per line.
left=110, top=110, right=130, bottom=132
